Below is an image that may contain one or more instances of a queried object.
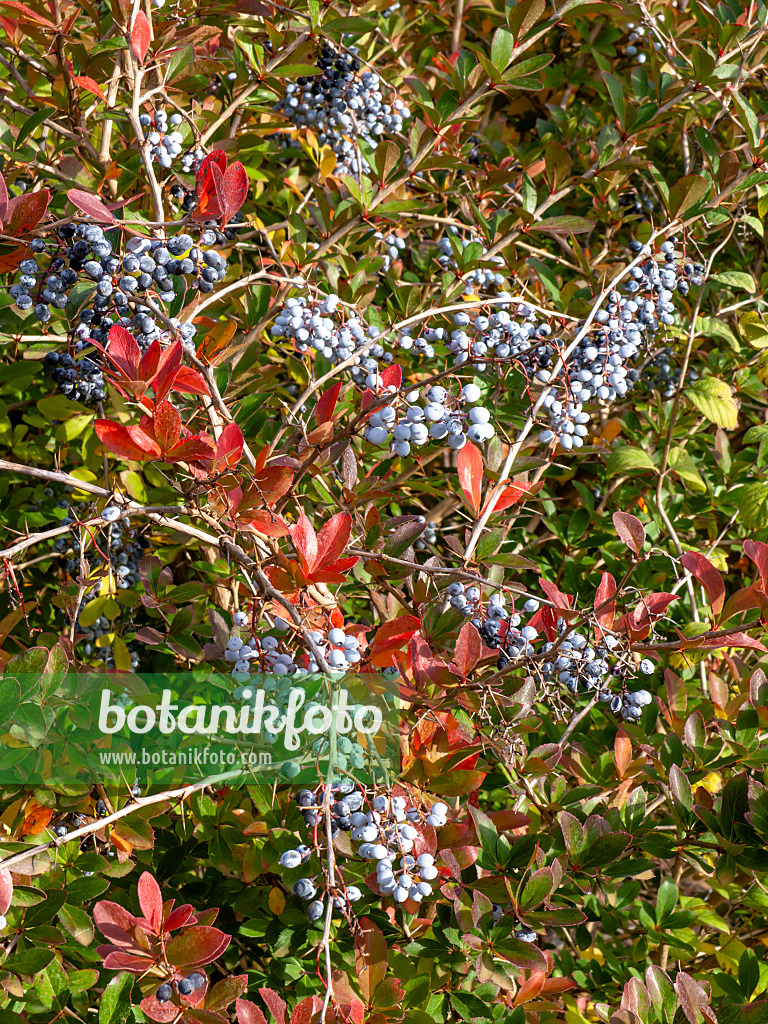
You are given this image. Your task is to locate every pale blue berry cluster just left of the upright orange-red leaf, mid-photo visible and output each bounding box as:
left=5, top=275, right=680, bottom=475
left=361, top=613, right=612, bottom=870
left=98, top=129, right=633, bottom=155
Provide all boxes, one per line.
left=365, top=374, right=496, bottom=458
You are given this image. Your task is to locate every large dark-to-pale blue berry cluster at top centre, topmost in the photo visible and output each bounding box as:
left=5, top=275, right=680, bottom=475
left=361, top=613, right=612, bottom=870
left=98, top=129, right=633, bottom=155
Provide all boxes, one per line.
left=274, top=43, right=411, bottom=174
